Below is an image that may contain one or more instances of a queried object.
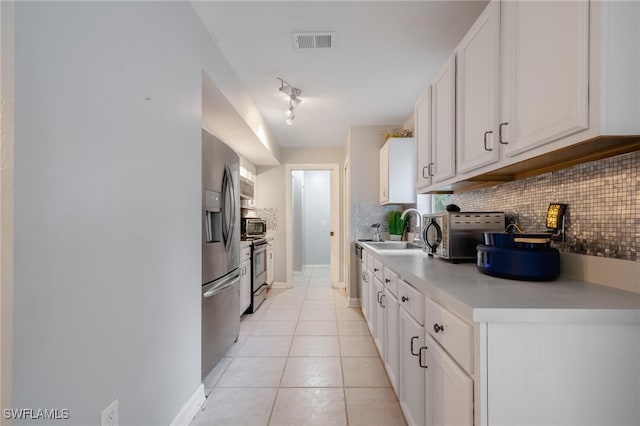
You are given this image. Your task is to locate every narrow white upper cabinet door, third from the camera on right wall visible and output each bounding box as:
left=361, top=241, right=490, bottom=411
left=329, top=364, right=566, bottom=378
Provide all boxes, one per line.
left=430, top=55, right=456, bottom=183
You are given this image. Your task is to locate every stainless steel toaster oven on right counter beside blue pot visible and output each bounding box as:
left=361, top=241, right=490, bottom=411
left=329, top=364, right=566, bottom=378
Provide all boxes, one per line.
left=422, top=211, right=504, bottom=262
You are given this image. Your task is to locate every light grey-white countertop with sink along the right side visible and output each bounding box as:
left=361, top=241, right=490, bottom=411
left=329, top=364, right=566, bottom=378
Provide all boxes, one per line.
left=358, top=242, right=640, bottom=324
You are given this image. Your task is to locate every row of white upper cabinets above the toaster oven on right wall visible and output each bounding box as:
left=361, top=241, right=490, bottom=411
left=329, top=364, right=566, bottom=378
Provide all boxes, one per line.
left=416, top=0, right=640, bottom=192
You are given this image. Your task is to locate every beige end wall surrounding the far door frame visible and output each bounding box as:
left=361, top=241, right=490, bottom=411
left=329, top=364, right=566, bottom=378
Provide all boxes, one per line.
left=256, top=148, right=344, bottom=282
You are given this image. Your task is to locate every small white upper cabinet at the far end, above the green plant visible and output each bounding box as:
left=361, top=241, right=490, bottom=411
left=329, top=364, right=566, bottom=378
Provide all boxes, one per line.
left=380, top=138, right=416, bottom=204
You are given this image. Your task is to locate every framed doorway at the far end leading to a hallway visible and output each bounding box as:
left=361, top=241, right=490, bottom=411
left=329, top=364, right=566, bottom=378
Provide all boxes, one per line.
left=286, top=164, right=340, bottom=287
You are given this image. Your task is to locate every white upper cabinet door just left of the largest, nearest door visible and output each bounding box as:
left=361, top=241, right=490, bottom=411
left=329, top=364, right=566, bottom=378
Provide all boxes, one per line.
left=456, top=1, right=502, bottom=173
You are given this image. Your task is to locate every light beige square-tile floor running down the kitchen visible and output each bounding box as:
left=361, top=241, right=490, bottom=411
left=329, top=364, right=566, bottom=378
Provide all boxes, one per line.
left=191, top=268, right=406, bottom=426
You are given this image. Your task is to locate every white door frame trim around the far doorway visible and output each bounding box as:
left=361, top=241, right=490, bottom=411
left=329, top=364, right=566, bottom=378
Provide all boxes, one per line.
left=284, top=163, right=343, bottom=288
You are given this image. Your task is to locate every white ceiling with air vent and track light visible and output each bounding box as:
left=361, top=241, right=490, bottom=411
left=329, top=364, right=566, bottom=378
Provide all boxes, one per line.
left=193, top=0, right=487, bottom=153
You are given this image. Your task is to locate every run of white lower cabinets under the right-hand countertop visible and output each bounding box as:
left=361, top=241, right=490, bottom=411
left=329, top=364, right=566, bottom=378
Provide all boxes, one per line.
left=362, top=246, right=640, bottom=426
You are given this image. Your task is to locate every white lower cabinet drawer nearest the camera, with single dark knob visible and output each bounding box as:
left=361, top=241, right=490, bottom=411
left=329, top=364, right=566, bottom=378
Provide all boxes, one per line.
left=424, top=298, right=473, bottom=373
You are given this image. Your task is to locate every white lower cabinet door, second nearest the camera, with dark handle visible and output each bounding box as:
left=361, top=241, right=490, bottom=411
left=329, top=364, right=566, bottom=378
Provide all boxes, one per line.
left=398, top=308, right=425, bottom=426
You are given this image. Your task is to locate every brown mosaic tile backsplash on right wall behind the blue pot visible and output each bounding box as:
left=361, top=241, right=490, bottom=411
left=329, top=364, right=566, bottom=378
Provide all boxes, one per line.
left=451, top=152, right=640, bottom=261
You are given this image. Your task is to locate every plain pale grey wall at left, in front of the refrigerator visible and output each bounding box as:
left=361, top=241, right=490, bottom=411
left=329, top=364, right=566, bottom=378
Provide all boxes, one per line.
left=12, top=2, right=258, bottom=425
